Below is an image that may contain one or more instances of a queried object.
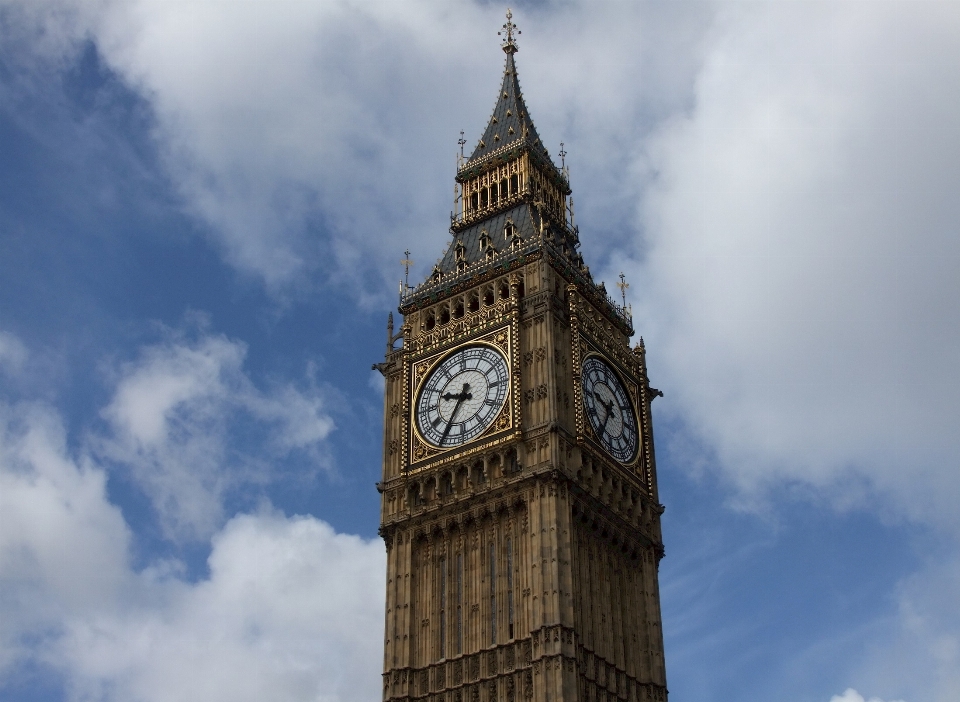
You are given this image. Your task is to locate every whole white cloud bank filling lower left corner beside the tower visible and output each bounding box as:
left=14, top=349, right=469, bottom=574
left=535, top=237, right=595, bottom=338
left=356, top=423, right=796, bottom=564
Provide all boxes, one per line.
left=0, top=398, right=385, bottom=702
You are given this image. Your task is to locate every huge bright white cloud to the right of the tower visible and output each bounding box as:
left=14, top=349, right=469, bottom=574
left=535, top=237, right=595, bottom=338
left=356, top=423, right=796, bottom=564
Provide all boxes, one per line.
left=632, top=3, right=960, bottom=531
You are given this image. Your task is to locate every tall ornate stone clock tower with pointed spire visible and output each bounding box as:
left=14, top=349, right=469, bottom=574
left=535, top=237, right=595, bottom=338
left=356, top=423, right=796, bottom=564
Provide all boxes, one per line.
left=376, top=12, right=667, bottom=702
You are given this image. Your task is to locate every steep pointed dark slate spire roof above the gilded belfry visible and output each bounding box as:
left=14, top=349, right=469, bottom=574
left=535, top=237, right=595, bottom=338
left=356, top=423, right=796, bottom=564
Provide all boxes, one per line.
left=460, top=51, right=556, bottom=176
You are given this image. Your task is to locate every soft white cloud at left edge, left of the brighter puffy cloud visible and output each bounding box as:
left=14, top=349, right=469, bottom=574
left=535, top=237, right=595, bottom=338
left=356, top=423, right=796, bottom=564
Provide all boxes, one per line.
left=0, top=403, right=130, bottom=674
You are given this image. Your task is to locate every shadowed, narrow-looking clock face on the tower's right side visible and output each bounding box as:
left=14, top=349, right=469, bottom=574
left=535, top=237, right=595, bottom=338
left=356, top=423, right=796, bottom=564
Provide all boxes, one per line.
left=581, top=356, right=639, bottom=463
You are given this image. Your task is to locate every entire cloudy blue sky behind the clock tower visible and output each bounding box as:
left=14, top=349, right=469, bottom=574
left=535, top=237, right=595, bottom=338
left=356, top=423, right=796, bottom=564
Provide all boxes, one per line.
left=0, top=0, right=960, bottom=702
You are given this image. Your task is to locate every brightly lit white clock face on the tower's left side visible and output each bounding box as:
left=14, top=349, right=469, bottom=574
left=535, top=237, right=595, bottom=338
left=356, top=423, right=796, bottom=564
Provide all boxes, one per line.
left=416, top=346, right=510, bottom=448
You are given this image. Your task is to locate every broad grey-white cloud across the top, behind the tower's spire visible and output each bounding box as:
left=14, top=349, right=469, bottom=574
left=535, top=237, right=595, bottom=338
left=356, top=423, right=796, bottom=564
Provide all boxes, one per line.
left=1, top=0, right=710, bottom=296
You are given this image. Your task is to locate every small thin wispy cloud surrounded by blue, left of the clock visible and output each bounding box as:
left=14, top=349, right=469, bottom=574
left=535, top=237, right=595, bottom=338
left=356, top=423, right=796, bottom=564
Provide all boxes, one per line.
left=96, top=332, right=333, bottom=539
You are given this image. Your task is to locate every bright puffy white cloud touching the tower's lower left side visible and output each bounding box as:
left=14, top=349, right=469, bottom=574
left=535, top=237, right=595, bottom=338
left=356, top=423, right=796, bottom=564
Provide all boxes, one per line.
left=52, top=514, right=386, bottom=702
